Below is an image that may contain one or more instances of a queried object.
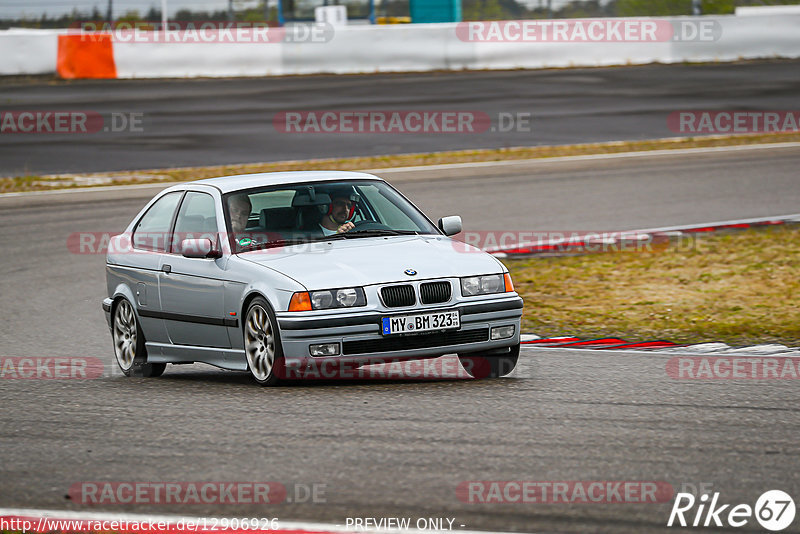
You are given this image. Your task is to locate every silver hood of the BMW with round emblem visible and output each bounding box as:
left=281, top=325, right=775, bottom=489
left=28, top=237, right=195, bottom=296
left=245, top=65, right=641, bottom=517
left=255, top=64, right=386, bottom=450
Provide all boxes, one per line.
left=239, top=236, right=505, bottom=290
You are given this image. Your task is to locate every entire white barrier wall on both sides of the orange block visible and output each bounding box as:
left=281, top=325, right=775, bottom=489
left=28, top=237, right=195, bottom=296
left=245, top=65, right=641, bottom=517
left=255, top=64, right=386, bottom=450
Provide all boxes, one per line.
left=0, top=15, right=800, bottom=78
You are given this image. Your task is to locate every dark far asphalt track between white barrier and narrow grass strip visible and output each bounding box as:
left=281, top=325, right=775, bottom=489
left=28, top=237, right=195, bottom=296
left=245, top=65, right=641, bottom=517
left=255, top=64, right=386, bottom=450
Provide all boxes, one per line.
left=0, top=60, right=800, bottom=176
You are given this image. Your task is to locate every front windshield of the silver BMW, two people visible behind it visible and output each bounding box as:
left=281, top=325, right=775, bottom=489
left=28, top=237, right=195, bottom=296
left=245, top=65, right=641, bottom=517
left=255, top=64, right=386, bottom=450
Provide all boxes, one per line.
left=225, top=180, right=439, bottom=252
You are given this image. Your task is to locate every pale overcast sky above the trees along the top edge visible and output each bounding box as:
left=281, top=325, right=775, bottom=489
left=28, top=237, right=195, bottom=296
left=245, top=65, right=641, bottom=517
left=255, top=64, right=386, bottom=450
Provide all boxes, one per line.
left=0, top=0, right=588, bottom=18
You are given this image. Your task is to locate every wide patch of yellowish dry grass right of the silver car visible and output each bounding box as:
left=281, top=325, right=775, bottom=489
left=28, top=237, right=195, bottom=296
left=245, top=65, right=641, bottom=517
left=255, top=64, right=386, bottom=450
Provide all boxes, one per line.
left=504, top=225, right=800, bottom=346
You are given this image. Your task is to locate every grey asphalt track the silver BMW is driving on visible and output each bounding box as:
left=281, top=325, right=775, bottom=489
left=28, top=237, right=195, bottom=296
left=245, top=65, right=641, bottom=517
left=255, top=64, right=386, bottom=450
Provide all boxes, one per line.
left=0, top=148, right=800, bottom=532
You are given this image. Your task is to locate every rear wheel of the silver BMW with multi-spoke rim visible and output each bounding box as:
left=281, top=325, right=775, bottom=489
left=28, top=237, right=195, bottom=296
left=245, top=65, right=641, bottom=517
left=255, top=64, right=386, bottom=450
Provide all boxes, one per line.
left=111, top=298, right=167, bottom=378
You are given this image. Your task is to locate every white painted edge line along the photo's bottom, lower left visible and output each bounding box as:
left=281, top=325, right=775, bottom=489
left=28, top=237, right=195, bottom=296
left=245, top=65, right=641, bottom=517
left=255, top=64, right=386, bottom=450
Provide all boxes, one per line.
left=0, top=508, right=532, bottom=534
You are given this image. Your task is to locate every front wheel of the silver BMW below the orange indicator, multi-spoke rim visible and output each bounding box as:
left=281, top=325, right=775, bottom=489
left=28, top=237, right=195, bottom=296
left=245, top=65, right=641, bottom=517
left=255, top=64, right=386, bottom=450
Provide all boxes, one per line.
left=242, top=297, right=285, bottom=386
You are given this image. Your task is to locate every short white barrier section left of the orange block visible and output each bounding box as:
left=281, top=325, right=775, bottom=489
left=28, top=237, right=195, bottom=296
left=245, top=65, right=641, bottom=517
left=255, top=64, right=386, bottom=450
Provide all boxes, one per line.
left=0, top=29, right=62, bottom=75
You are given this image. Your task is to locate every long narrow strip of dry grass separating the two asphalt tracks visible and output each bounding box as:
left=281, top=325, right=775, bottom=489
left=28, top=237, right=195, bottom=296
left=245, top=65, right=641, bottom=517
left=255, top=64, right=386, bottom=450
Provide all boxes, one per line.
left=0, top=132, right=800, bottom=193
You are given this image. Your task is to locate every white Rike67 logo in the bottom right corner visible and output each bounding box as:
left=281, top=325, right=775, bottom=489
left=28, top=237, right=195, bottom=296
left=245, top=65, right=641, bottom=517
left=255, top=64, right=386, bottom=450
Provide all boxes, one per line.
left=667, top=490, right=797, bottom=532
